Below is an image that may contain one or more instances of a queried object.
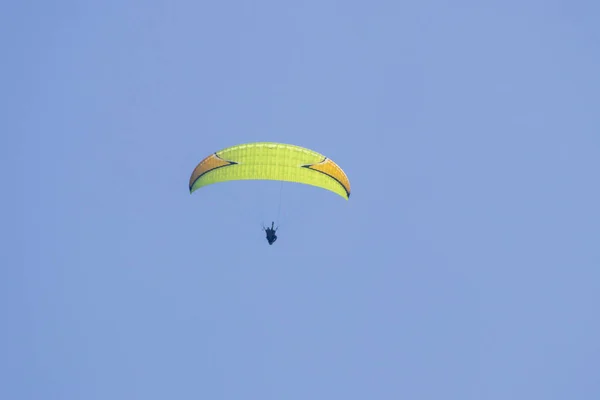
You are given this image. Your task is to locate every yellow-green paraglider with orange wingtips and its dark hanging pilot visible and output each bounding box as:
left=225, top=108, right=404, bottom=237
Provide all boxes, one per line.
left=189, top=142, right=350, bottom=245
